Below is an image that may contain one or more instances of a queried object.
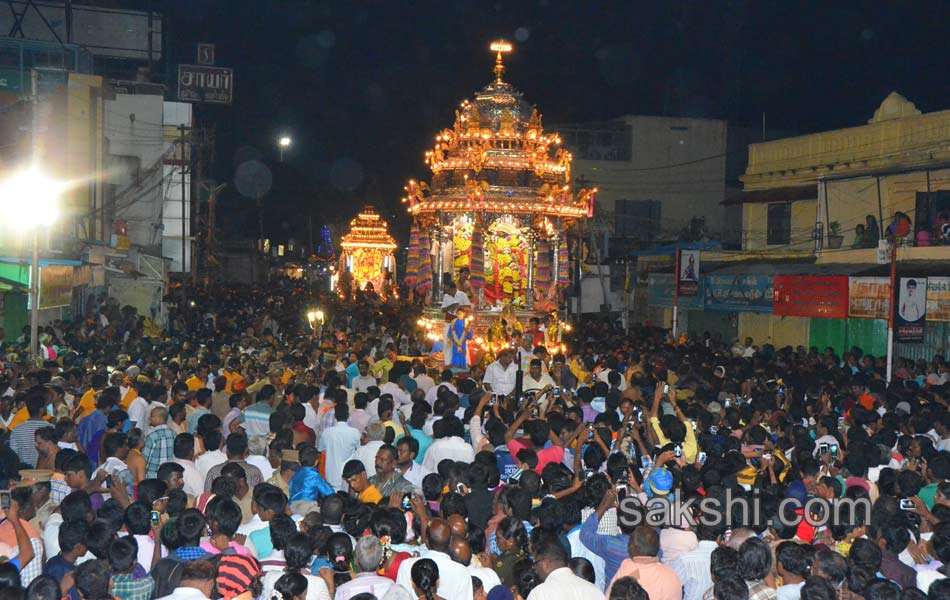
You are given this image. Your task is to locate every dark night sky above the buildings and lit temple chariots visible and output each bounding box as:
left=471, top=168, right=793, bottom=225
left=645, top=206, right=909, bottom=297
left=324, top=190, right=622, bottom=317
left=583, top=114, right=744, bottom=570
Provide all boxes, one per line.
left=163, top=0, right=950, bottom=244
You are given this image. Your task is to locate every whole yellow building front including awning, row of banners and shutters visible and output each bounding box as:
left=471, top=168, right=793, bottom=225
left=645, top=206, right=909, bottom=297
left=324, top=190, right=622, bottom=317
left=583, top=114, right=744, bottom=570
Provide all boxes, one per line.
left=654, top=93, right=950, bottom=360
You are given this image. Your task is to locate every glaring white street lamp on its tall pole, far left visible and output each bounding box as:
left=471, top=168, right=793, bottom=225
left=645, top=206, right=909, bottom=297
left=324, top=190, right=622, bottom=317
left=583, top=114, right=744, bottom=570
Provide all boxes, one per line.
left=0, top=166, right=63, bottom=365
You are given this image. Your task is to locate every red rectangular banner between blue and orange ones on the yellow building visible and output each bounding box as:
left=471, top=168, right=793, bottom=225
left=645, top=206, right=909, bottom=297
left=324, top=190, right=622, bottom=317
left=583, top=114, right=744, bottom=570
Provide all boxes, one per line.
left=772, top=275, right=848, bottom=319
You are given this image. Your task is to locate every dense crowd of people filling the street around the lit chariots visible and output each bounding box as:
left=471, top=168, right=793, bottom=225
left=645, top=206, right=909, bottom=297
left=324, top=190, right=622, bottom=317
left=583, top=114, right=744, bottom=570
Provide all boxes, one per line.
left=0, top=286, right=950, bottom=600
